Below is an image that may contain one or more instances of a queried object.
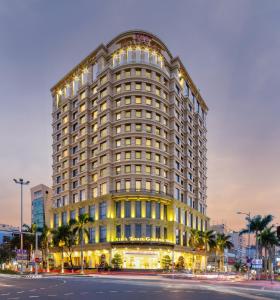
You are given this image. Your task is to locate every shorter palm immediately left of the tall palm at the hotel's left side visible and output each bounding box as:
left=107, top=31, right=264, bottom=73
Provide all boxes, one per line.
left=52, top=225, right=76, bottom=273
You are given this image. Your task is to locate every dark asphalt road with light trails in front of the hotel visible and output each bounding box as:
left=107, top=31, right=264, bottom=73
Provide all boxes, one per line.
left=0, top=276, right=280, bottom=300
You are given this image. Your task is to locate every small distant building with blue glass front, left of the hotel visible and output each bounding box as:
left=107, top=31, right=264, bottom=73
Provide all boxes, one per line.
left=31, top=184, right=52, bottom=228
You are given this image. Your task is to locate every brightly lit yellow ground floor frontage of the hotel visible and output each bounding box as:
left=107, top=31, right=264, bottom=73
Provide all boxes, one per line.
left=53, top=243, right=206, bottom=271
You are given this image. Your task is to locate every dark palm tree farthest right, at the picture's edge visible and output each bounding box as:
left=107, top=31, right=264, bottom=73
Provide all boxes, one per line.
left=259, top=227, right=279, bottom=278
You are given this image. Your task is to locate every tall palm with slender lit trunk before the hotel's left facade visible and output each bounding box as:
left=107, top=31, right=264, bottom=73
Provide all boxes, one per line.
left=70, top=214, right=93, bottom=274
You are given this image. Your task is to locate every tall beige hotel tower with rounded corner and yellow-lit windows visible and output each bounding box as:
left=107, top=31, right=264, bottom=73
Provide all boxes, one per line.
left=50, top=31, right=208, bottom=269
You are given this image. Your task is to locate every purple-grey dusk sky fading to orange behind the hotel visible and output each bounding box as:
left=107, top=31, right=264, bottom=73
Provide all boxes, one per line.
left=0, top=0, right=280, bottom=230
